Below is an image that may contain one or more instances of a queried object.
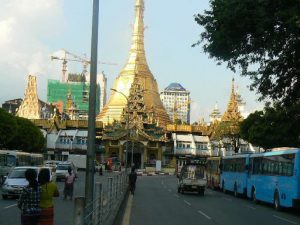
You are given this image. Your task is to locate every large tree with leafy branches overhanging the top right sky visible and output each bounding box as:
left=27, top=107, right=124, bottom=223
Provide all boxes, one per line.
left=193, top=0, right=300, bottom=105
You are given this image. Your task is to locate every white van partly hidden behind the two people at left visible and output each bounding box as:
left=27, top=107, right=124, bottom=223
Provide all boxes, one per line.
left=2, top=166, right=56, bottom=199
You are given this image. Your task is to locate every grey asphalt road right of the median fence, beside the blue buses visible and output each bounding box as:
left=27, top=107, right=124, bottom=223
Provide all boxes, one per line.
left=127, top=176, right=300, bottom=225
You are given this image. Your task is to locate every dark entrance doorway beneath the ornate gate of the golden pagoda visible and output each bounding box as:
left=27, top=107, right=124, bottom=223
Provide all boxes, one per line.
left=123, top=141, right=144, bottom=169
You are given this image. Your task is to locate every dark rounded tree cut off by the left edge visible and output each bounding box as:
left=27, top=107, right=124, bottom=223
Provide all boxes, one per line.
left=0, top=109, right=17, bottom=148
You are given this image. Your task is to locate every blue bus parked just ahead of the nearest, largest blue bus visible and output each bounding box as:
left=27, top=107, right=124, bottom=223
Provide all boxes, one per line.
left=220, top=154, right=250, bottom=196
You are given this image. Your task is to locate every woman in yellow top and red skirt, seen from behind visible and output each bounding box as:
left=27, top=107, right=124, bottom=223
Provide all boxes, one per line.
left=38, top=168, right=59, bottom=225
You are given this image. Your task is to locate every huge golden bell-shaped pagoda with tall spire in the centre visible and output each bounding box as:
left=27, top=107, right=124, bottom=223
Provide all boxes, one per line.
left=97, top=0, right=170, bottom=127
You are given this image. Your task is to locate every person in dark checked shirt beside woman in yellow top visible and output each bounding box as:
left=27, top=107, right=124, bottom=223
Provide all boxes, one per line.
left=17, top=169, right=41, bottom=225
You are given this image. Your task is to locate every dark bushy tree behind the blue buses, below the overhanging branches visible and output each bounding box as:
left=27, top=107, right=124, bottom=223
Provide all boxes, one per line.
left=240, top=103, right=300, bottom=149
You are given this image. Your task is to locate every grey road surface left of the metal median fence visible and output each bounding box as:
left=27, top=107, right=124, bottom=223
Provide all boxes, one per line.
left=0, top=172, right=121, bottom=225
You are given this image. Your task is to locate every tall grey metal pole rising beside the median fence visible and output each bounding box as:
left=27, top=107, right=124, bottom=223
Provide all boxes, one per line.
left=85, top=0, right=99, bottom=218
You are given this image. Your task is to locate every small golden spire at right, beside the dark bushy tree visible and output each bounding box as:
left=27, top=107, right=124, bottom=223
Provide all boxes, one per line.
left=222, top=78, right=242, bottom=121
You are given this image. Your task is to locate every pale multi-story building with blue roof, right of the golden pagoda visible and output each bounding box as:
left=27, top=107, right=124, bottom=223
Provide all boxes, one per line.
left=160, top=83, right=191, bottom=124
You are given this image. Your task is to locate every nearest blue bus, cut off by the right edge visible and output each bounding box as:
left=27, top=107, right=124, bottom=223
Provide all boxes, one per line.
left=247, top=148, right=300, bottom=209
